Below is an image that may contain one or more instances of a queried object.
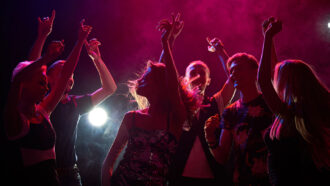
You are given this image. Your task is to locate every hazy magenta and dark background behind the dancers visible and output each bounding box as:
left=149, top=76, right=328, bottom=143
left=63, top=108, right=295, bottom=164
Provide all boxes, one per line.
left=1, top=0, right=330, bottom=185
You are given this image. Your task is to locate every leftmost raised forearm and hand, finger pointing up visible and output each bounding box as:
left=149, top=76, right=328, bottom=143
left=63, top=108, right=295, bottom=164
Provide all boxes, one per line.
left=28, top=10, right=55, bottom=61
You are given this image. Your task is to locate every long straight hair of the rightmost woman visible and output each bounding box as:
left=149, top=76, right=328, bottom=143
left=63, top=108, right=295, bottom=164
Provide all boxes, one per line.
left=274, top=59, right=330, bottom=168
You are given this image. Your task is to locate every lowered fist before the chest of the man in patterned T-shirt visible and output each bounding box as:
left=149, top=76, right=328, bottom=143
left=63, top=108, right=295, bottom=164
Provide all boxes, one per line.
left=204, top=114, right=220, bottom=148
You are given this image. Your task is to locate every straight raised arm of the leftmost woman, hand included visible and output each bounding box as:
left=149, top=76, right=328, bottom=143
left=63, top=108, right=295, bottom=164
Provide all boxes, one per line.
left=40, top=20, right=92, bottom=115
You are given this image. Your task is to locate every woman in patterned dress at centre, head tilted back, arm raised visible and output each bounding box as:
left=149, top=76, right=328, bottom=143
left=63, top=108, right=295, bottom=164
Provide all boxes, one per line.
left=102, top=13, right=193, bottom=186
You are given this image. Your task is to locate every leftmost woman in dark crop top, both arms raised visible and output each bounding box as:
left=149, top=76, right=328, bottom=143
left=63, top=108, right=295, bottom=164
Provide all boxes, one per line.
left=5, top=17, right=91, bottom=185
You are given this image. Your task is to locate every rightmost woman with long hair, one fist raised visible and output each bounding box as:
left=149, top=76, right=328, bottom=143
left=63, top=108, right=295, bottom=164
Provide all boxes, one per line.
left=258, top=19, right=330, bottom=185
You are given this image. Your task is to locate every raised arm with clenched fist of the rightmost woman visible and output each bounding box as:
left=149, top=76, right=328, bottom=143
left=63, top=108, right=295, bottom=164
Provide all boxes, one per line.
left=258, top=20, right=285, bottom=114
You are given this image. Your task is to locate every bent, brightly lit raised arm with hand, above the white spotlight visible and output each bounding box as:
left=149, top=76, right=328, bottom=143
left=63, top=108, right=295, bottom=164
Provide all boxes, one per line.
left=85, top=38, right=117, bottom=105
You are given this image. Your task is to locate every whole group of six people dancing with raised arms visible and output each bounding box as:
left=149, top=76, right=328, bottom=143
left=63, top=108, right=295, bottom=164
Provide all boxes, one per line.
left=4, top=11, right=330, bottom=186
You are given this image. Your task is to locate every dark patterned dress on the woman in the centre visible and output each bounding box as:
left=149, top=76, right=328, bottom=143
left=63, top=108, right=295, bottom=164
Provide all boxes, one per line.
left=111, top=127, right=177, bottom=186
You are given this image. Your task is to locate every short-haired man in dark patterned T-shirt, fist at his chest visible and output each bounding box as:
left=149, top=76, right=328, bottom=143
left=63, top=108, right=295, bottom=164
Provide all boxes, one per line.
left=205, top=53, right=272, bottom=185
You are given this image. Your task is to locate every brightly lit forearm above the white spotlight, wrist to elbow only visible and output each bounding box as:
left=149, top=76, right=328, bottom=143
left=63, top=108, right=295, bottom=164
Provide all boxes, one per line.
left=93, top=57, right=117, bottom=95
